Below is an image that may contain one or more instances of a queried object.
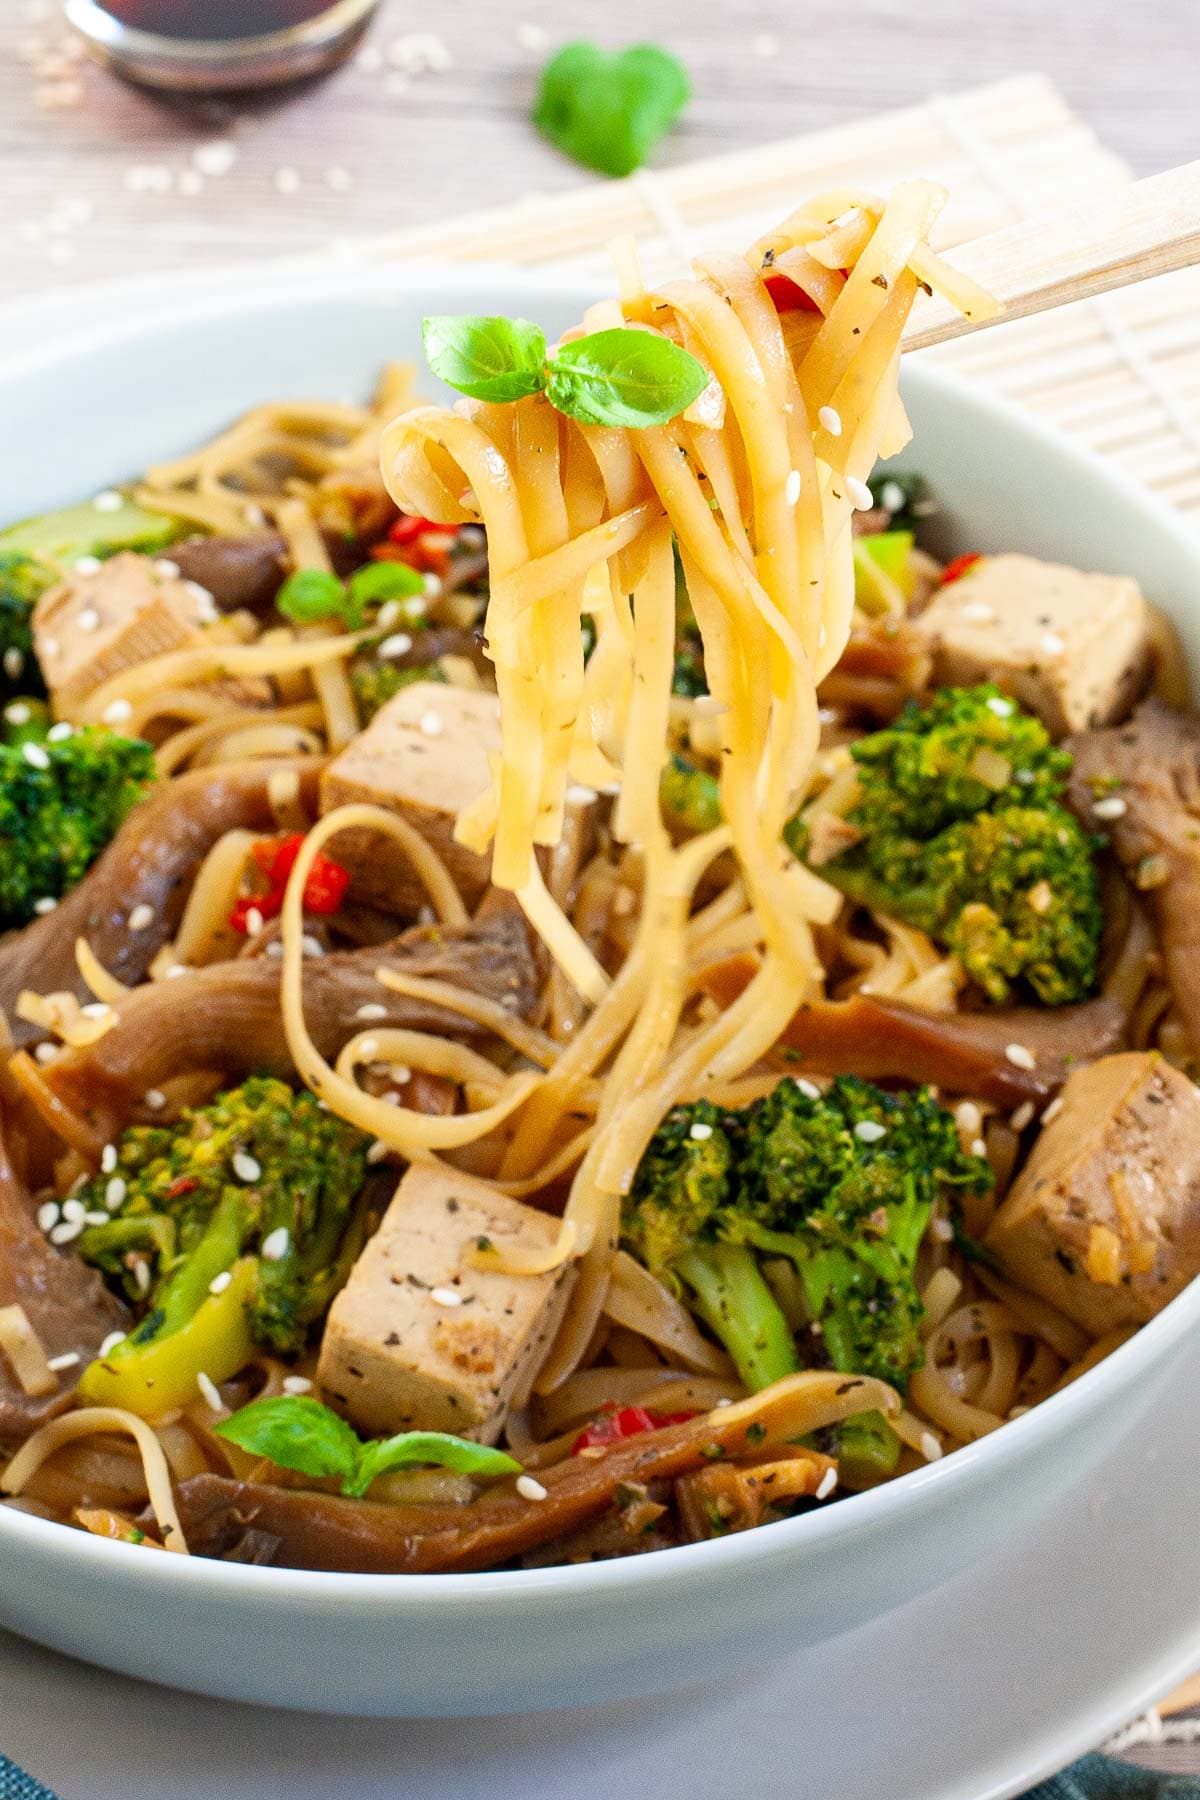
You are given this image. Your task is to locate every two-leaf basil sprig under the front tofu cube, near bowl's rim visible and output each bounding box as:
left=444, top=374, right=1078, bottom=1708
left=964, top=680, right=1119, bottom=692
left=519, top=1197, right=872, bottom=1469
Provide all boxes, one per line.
left=216, top=1393, right=522, bottom=1499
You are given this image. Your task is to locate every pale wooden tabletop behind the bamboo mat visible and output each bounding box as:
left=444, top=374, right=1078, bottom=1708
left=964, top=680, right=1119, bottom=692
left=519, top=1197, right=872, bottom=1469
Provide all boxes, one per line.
left=0, top=0, right=1200, bottom=297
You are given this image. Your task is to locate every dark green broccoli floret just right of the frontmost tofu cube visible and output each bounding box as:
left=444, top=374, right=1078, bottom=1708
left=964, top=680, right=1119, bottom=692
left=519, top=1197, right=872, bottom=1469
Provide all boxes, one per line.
left=621, top=1076, right=991, bottom=1391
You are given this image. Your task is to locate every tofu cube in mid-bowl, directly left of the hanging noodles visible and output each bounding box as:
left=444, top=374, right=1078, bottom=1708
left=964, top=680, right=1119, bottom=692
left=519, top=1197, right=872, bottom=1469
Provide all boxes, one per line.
left=320, top=680, right=500, bottom=913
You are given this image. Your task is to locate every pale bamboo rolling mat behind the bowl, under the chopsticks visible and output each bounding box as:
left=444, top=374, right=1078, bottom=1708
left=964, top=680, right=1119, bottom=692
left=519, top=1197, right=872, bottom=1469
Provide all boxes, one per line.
left=353, top=76, right=1200, bottom=518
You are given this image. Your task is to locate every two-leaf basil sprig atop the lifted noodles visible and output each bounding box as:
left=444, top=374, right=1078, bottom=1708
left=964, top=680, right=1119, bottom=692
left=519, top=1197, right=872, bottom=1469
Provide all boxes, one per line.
left=421, top=313, right=709, bottom=430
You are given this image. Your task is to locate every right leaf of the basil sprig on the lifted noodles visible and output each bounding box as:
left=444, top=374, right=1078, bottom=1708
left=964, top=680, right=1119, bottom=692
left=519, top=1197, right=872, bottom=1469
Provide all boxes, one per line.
left=545, top=328, right=709, bottom=428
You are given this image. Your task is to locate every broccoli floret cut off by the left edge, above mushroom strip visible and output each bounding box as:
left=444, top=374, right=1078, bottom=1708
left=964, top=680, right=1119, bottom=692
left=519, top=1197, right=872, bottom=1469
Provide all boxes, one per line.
left=0, top=720, right=155, bottom=929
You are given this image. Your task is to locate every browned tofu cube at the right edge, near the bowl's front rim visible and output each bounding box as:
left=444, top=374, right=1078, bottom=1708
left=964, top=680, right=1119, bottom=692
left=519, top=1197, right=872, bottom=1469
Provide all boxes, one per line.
left=988, top=1051, right=1200, bottom=1337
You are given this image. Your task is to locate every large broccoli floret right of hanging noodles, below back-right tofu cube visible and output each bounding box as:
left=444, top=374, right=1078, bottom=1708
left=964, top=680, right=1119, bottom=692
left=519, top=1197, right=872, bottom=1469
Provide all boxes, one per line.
left=786, top=686, right=1103, bottom=1006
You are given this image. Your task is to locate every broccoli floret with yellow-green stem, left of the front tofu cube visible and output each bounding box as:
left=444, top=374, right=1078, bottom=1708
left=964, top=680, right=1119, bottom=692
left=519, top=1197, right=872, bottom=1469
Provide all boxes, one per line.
left=79, top=1076, right=369, bottom=1364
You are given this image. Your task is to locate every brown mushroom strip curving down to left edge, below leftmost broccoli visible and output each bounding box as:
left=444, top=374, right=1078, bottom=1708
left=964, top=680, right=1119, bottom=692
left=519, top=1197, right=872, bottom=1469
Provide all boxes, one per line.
left=0, top=758, right=320, bottom=1046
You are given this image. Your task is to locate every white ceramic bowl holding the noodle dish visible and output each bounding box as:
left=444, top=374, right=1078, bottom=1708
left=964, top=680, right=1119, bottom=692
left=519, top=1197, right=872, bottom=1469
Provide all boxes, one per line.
left=0, top=268, right=1200, bottom=1715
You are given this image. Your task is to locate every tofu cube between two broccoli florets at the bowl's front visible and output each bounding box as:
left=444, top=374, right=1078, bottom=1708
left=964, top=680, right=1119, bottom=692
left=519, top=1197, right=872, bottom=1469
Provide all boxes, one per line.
left=318, top=1163, right=574, bottom=1444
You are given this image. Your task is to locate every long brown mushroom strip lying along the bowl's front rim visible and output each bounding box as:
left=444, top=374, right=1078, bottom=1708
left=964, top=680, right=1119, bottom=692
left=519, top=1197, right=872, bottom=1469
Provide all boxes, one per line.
left=157, top=1370, right=900, bottom=1575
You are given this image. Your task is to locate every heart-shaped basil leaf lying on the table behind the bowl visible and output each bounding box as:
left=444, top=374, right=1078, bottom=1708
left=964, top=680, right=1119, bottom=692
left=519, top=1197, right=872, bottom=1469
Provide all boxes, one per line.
left=533, top=43, right=691, bottom=175
